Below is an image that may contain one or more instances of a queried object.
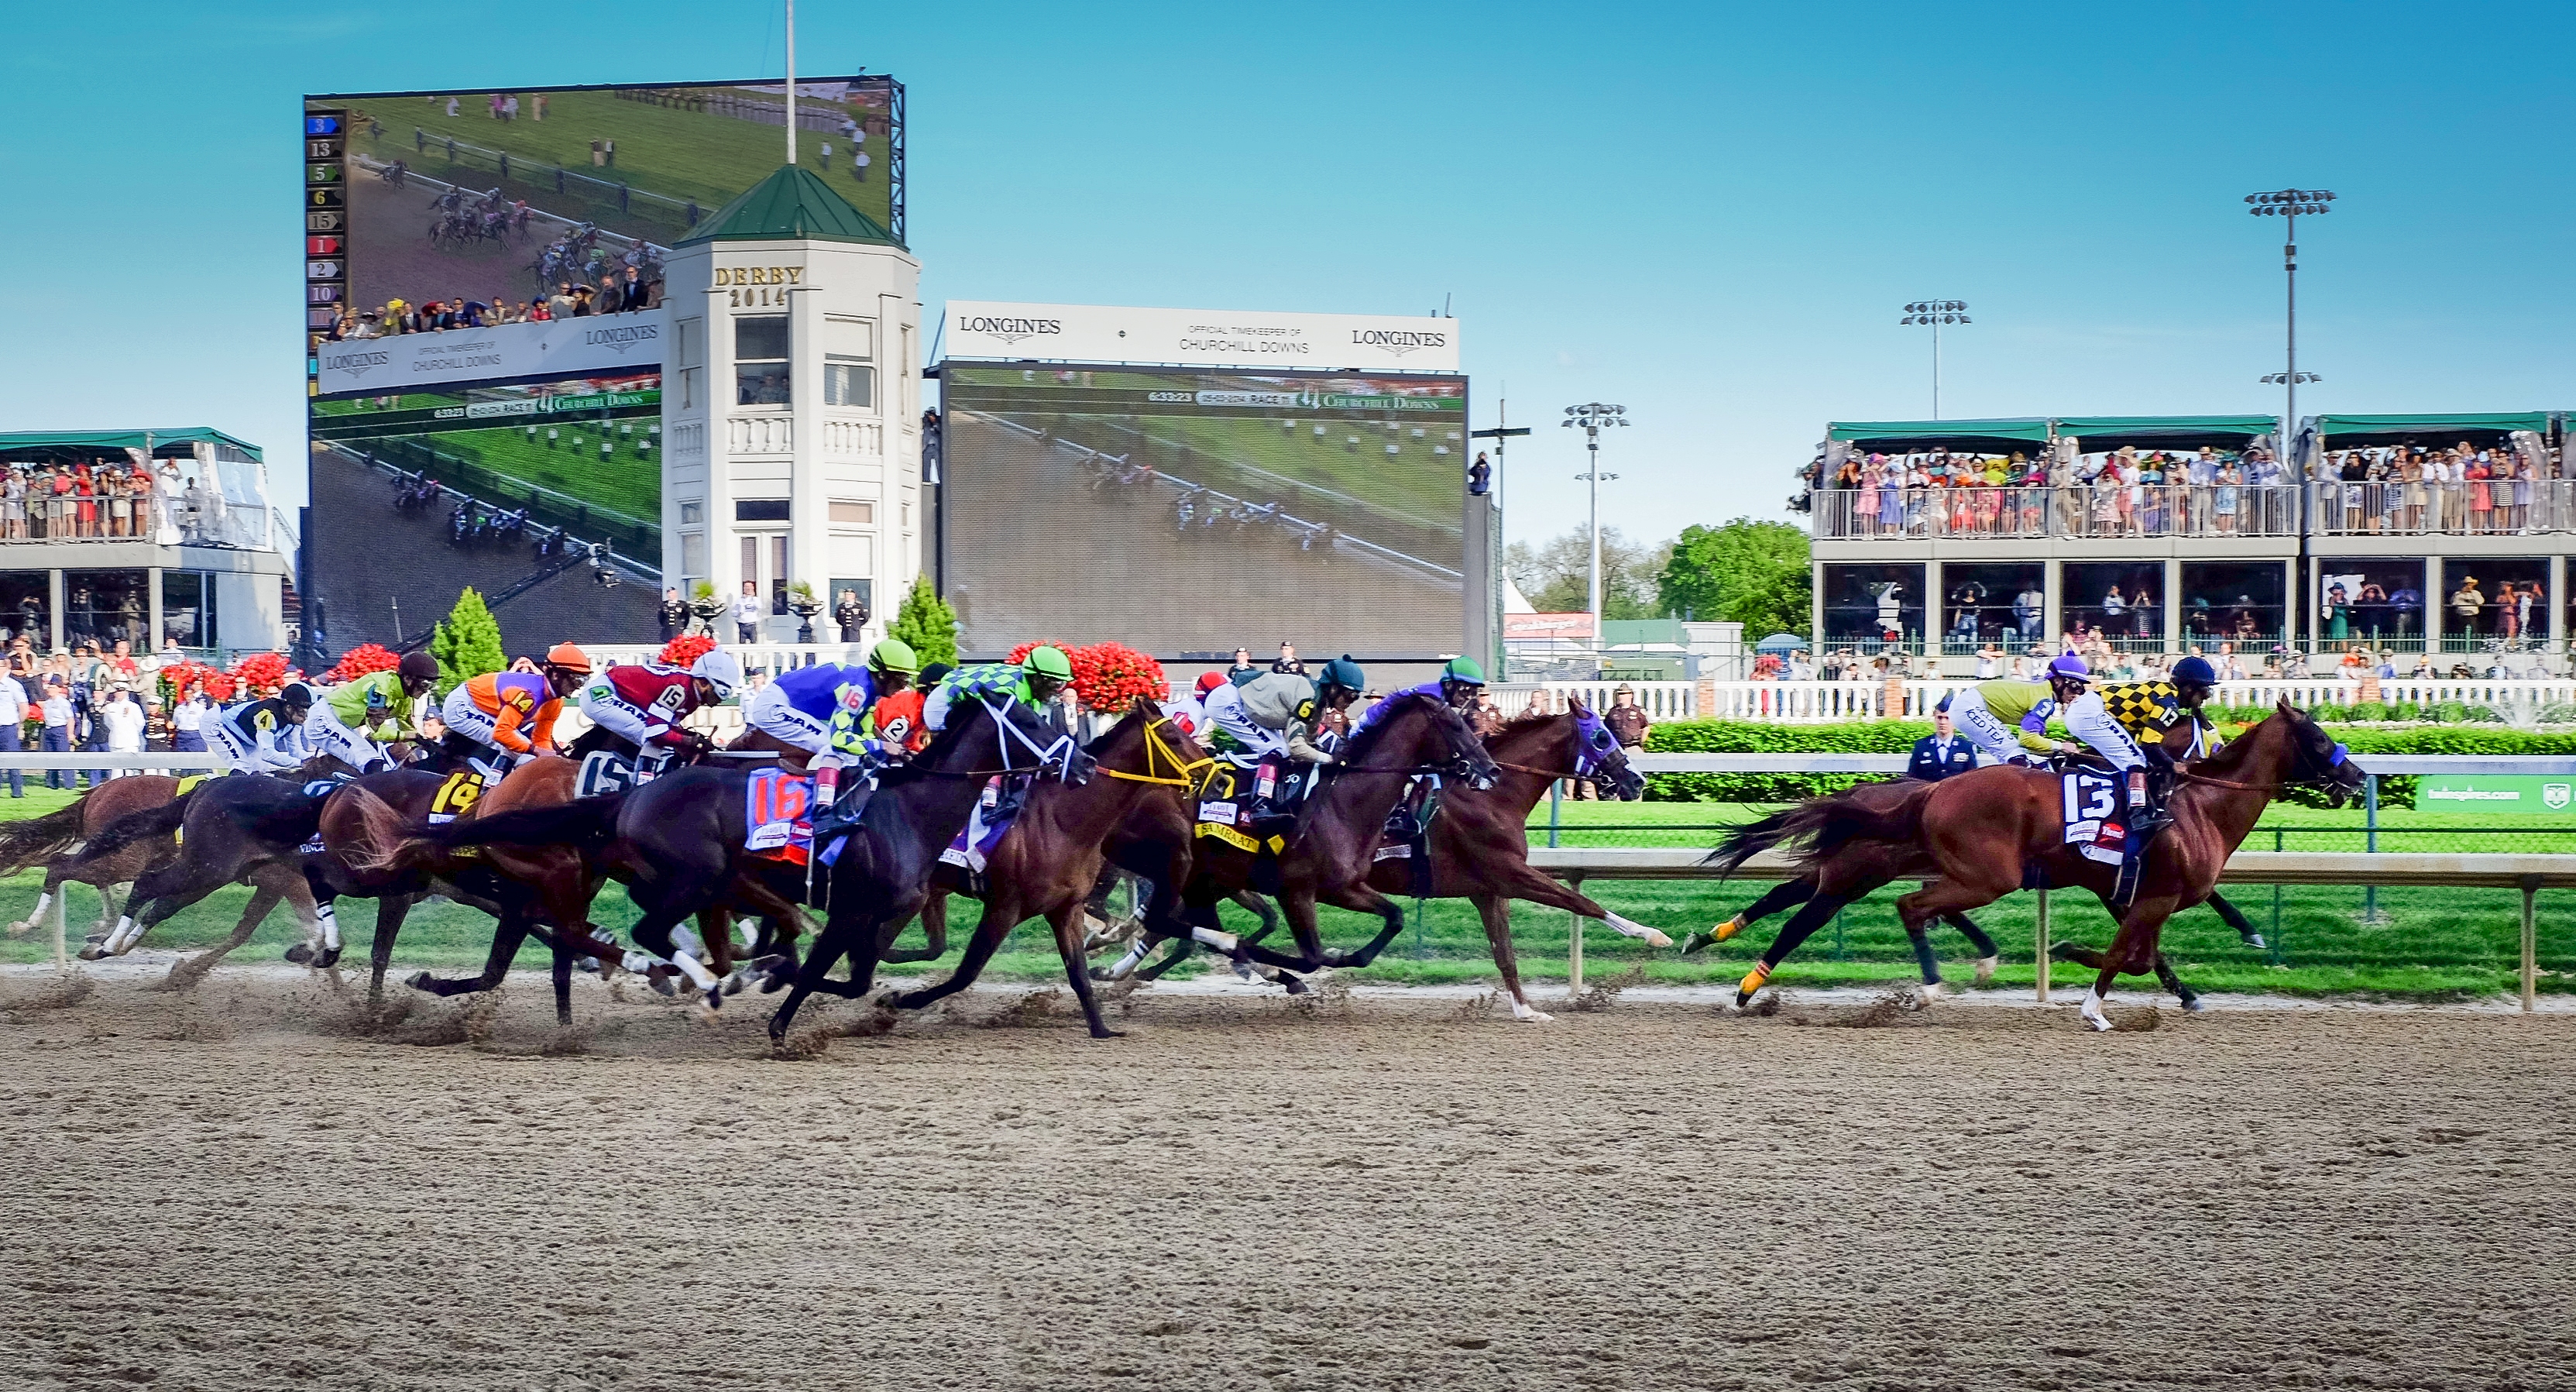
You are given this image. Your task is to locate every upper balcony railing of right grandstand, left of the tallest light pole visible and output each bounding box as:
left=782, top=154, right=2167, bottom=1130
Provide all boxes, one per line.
left=1814, top=485, right=2298, bottom=541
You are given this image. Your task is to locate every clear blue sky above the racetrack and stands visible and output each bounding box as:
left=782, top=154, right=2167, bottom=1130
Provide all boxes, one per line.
left=0, top=0, right=2576, bottom=539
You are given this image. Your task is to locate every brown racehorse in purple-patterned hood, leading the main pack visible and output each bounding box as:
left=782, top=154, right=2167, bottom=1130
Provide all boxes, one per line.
left=1144, top=701, right=1672, bottom=1023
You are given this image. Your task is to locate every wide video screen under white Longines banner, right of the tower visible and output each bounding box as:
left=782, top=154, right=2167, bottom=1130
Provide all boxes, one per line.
left=940, top=361, right=1468, bottom=658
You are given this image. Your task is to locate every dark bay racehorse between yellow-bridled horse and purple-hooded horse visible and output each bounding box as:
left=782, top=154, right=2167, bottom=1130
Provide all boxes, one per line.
left=1111, top=693, right=1502, bottom=972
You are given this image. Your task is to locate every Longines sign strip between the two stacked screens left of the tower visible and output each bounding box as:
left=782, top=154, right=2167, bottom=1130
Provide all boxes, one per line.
left=317, top=309, right=662, bottom=397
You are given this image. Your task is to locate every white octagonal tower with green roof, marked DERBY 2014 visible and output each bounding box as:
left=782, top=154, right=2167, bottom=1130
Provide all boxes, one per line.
left=662, top=165, right=922, bottom=642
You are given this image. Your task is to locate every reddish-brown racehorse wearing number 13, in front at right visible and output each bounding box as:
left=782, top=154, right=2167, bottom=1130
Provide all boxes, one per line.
left=1708, top=701, right=2362, bottom=1029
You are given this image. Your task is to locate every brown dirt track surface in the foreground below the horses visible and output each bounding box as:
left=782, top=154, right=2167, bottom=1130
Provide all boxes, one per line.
left=0, top=972, right=2576, bottom=1392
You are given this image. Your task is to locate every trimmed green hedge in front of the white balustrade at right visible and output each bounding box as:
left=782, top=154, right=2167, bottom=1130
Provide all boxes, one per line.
left=1646, top=719, right=2576, bottom=807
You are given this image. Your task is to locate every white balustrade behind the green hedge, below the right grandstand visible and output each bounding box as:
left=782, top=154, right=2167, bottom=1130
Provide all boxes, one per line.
left=1702, top=675, right=2576, bottom=724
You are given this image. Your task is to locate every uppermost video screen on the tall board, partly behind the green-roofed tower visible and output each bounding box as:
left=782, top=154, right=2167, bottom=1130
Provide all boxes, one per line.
left=304, top=77, right=904, bottom=338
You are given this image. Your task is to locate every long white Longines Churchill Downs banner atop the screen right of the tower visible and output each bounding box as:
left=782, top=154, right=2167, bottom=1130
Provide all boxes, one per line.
left=946, top=299, right=1458, bottom=371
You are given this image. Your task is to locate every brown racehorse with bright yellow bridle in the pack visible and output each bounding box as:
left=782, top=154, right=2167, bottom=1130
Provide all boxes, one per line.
left=888, top=696, right=1214, bottom=1039
